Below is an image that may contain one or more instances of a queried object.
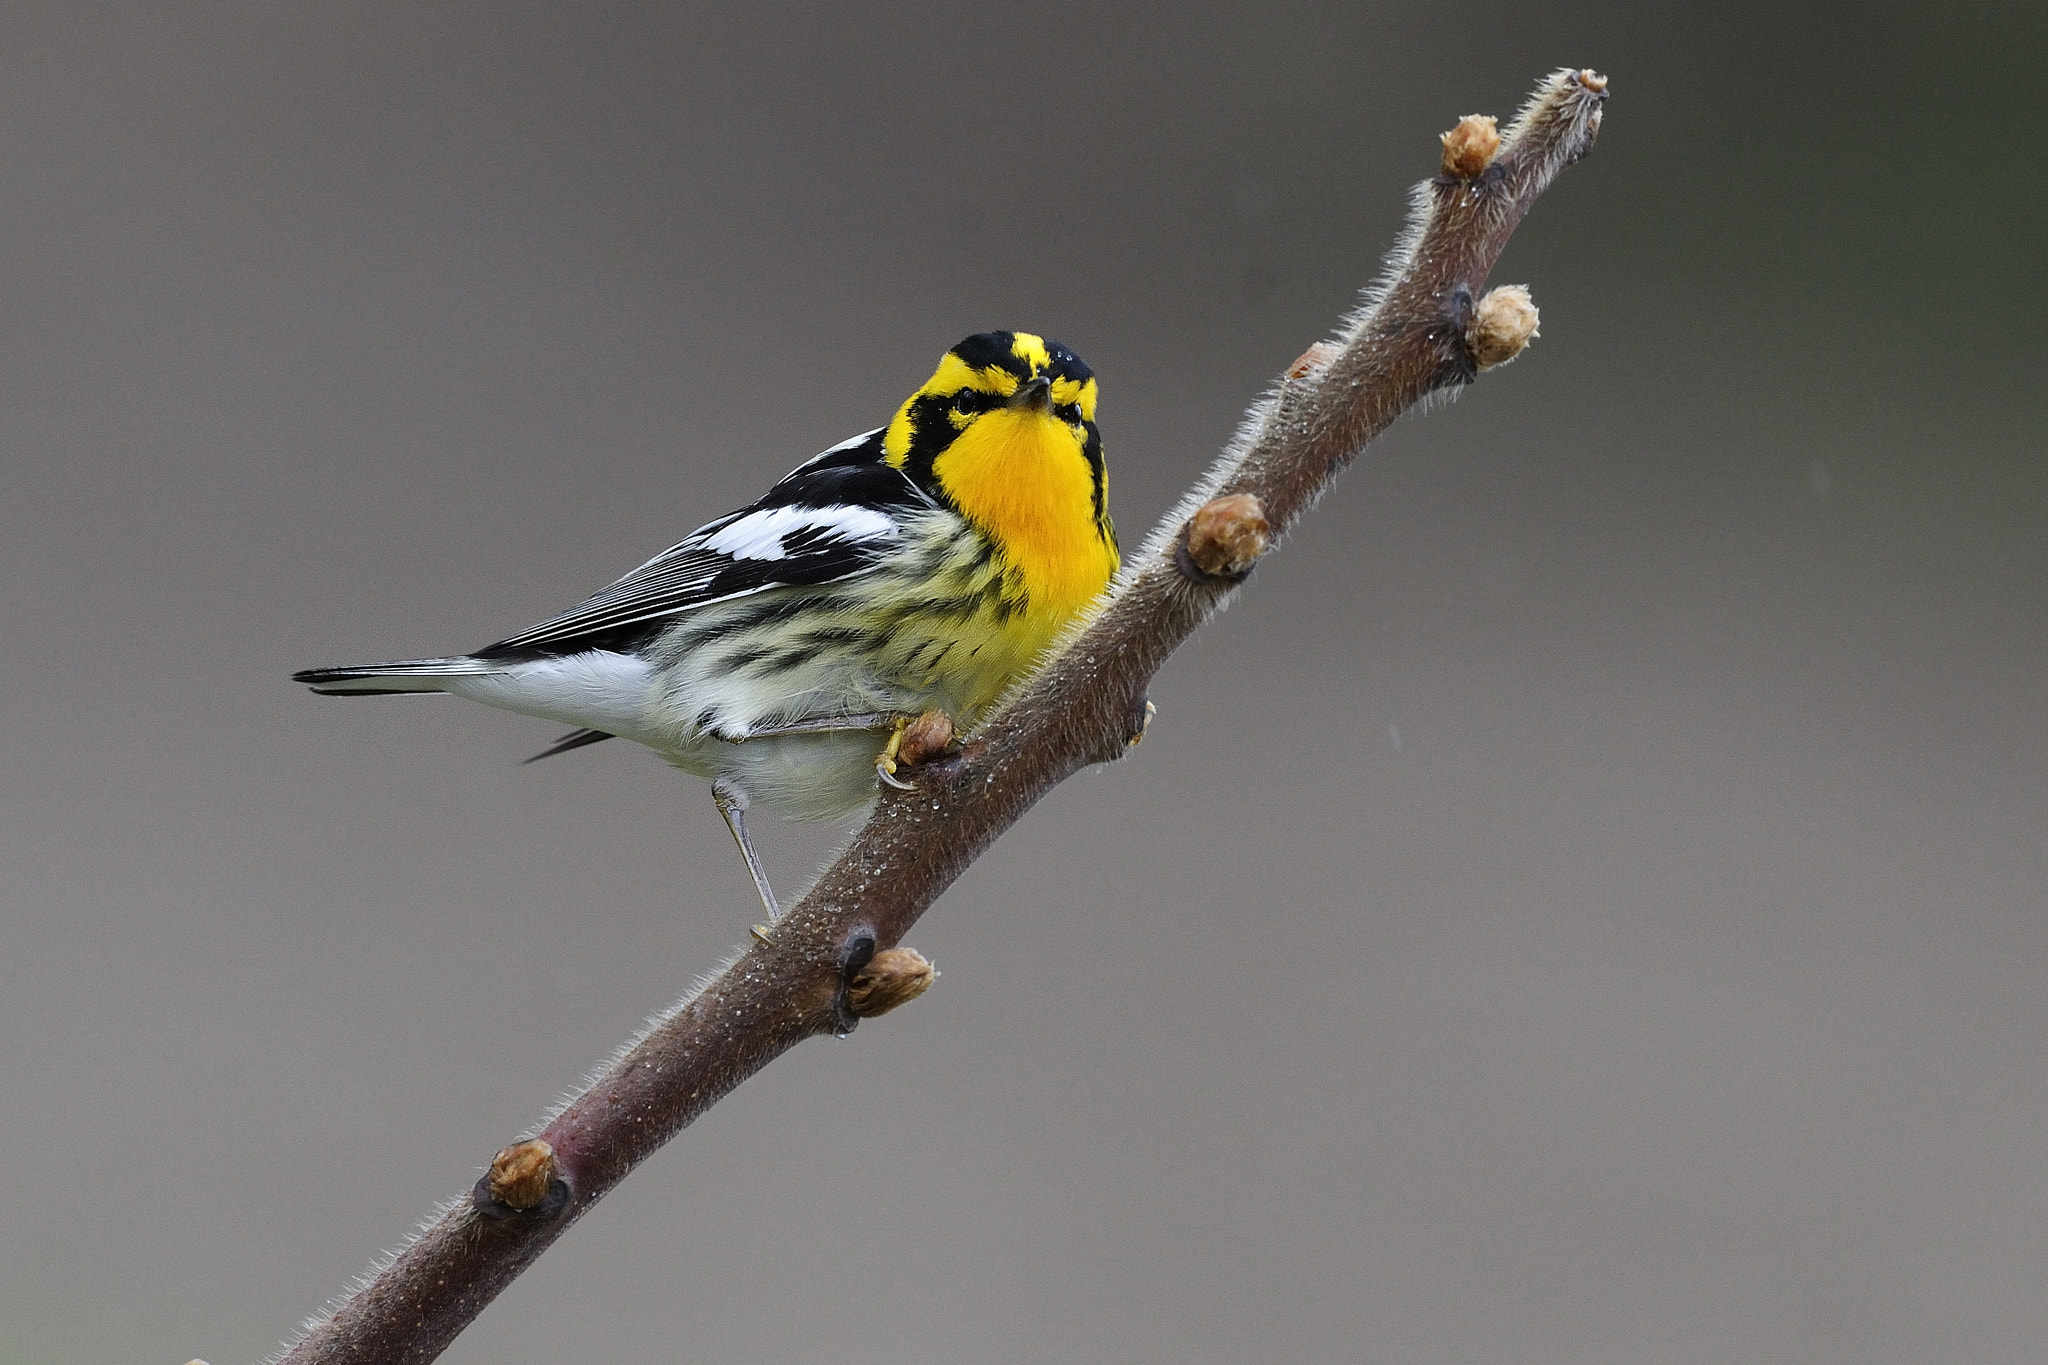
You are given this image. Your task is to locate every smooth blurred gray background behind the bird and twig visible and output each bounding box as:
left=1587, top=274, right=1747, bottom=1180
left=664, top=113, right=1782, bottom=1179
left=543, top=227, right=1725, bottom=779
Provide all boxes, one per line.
left=0, top=2, right=2048, bottom=1365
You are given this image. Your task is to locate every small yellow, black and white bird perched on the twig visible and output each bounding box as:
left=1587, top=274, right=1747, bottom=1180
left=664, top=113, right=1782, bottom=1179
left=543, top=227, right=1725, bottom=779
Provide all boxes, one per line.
left=293, top=332, right=1118, bottom=937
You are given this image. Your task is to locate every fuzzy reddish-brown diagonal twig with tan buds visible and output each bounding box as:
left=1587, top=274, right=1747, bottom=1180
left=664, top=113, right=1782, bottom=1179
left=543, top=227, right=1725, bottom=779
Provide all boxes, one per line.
left=276, top=72, right=1606, bottom=1363
